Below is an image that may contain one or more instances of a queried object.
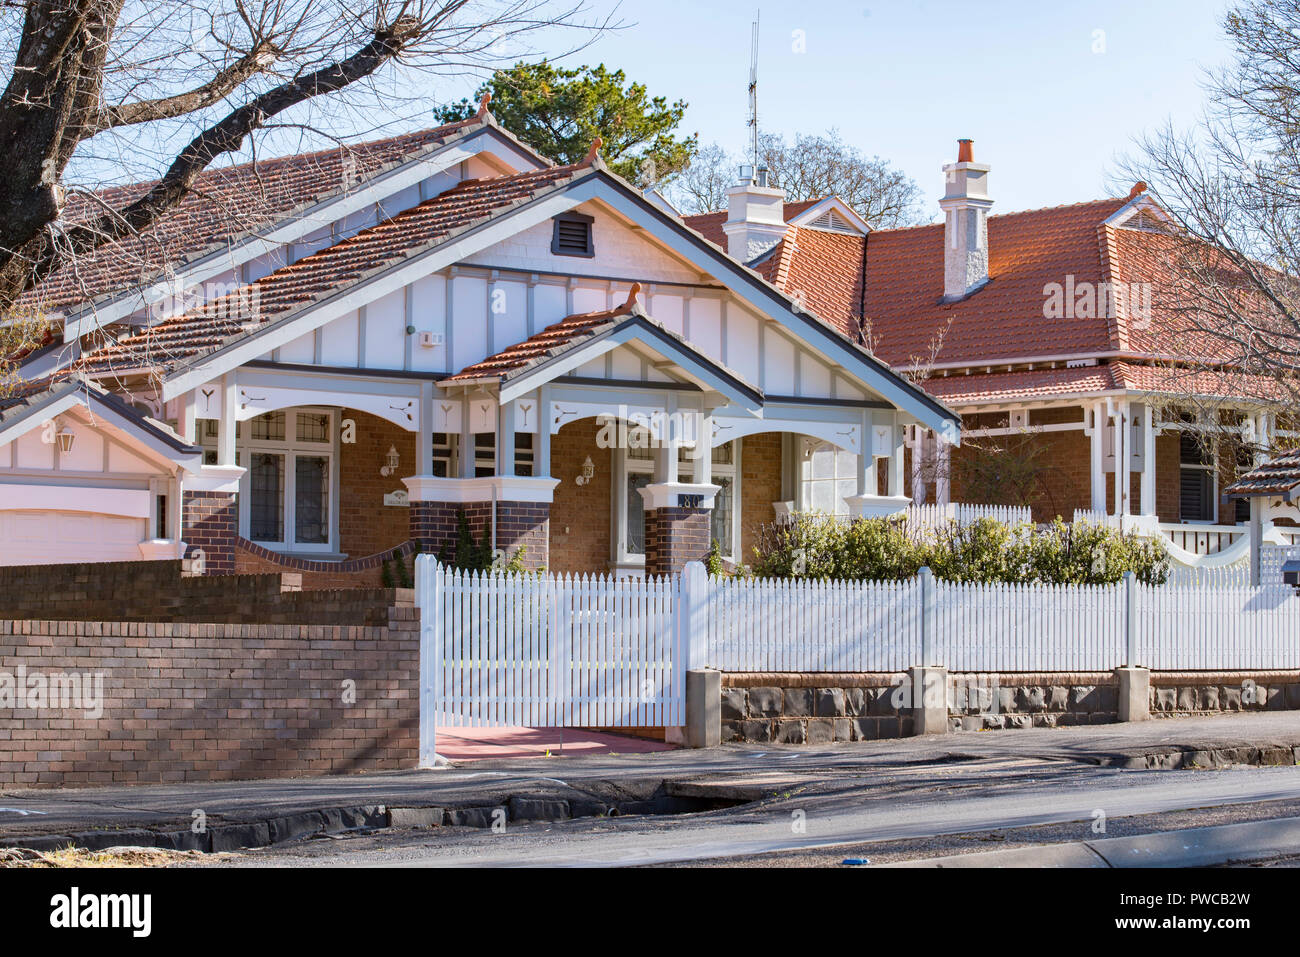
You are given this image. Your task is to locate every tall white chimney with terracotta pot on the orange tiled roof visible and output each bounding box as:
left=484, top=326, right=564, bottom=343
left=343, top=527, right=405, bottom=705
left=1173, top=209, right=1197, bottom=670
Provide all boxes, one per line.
left=939, top=139, right=993, bottom=300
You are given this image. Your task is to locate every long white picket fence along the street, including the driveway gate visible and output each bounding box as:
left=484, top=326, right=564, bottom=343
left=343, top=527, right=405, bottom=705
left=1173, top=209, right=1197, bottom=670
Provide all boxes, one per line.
left=416, top=549, right=1300, bottom=763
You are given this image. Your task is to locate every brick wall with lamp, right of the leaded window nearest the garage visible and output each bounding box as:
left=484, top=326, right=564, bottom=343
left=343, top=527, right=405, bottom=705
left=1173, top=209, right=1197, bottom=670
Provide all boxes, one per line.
left=338, top=408, right=416, bottom=558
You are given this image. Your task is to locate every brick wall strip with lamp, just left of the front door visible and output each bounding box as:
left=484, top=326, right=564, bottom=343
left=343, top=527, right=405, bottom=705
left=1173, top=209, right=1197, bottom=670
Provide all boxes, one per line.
left=549, top=419, right=614, bottom=573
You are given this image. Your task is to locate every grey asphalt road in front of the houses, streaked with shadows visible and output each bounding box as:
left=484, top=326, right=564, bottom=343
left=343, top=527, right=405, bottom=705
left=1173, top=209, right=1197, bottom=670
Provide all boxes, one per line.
left=225, top=758, right=1300, bottom=867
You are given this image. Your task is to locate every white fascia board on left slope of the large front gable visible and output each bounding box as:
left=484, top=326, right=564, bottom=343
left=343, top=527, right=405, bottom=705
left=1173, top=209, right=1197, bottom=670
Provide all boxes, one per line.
left=163, top=192, right=585, bottom=400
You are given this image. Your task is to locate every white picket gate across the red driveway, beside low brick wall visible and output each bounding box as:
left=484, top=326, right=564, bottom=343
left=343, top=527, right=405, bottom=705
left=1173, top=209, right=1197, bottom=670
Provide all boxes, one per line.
left=416, top=555, right=703, bottom=763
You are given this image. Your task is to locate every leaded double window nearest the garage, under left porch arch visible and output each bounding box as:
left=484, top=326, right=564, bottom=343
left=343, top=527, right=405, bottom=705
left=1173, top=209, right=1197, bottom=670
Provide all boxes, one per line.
left=199, top=408, right=337, bottom=551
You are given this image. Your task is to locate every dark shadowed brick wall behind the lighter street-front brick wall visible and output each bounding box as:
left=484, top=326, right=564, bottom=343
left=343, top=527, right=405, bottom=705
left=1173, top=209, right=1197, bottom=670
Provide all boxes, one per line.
left=0, top=560, right=415, bottom=625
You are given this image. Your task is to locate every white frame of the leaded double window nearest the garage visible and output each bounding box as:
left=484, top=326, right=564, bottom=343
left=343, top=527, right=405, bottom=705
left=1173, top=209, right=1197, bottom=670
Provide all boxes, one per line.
left=235, top=406, right=341, bottom=557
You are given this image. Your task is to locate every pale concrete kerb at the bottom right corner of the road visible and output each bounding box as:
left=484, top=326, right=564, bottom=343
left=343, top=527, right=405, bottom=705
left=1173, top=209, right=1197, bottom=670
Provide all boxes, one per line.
left=880, top=818, right=1300, bottom=867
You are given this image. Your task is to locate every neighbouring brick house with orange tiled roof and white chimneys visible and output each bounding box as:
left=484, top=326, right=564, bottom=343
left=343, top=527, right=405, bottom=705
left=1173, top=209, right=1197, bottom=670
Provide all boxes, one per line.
left=686, top=140, right=1297, bottom=564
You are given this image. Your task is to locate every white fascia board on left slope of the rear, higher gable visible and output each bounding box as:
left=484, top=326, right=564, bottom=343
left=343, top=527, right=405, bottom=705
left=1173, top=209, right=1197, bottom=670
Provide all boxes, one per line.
left=64, top=127, right=541, bottom=342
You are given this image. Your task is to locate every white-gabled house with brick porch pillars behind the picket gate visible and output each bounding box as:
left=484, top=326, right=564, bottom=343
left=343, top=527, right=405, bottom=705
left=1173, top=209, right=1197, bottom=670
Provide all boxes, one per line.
left=0, top=100, right=961, bottom=586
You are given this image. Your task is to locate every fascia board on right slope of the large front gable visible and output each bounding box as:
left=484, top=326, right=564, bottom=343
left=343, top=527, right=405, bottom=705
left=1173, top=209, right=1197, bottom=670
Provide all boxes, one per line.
left=585, top=179, right=959, bottom=436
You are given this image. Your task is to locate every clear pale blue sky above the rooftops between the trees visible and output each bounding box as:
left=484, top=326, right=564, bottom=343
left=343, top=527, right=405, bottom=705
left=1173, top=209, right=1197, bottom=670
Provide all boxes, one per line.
left=473, top=0, right=1229, bottom=212
